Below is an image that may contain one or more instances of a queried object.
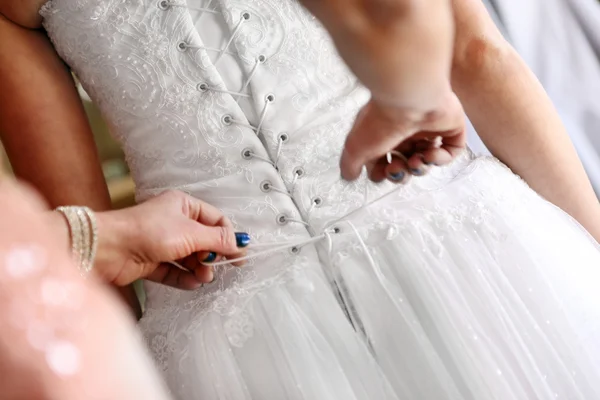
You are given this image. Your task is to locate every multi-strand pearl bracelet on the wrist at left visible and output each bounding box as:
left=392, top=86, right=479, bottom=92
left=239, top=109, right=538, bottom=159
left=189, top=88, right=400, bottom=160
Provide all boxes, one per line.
left=56, top=206, right=98, bottom=276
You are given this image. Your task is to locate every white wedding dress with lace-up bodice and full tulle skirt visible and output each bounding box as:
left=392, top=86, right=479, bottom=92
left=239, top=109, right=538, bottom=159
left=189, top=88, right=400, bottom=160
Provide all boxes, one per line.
left=42, top=0, right=600, bottom=400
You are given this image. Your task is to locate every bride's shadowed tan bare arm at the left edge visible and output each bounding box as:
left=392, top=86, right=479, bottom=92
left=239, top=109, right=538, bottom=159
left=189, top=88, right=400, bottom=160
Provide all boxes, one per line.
left=0, top=11, right=139, bottom=314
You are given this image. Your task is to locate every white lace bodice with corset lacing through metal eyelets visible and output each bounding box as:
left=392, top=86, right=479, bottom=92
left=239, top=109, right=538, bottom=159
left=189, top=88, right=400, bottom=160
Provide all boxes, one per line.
left=42, top=0, right=476, bottom=322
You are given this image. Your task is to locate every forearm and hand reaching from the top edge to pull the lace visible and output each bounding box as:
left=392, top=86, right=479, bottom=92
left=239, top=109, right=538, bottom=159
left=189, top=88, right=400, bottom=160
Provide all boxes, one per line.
left=302, top=0, right=465, bottom=182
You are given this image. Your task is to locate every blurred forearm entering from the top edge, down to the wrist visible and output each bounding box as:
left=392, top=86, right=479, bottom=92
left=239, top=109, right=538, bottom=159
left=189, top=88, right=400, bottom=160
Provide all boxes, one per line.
left=303, top=0, right=454, bottom=114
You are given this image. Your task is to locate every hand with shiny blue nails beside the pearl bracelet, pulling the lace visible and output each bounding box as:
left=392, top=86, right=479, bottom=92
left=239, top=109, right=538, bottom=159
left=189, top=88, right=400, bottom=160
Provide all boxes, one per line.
left=95, top=191, right=250, bottom=290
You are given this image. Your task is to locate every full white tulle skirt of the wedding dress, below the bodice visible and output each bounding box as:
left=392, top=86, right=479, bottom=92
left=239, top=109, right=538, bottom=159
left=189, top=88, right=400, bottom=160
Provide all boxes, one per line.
left=141, top=159, right=600, bottom=400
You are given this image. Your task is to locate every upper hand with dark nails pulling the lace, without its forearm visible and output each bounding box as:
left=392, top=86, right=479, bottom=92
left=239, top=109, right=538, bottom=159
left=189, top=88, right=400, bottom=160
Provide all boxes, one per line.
left=341, top=92, right=466, bottom=183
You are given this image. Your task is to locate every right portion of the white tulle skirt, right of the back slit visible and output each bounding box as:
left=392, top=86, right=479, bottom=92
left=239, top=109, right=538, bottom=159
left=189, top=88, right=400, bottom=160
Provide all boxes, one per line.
left=336, top=160, right=600, bottom=400
